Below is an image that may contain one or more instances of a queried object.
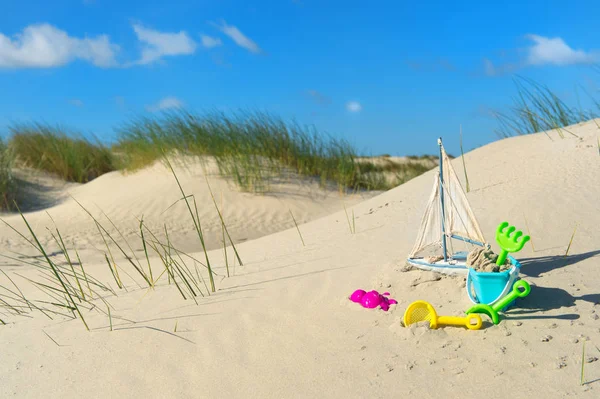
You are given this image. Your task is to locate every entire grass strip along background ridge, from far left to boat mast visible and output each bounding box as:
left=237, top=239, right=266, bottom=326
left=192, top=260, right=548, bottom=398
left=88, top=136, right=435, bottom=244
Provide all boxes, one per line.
left=2, top=110, right=436, bottom=196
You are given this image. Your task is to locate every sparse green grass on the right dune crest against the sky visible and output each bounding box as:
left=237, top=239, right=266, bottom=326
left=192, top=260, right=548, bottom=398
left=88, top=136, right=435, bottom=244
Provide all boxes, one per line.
left=494, top=75, right=600, bottom=138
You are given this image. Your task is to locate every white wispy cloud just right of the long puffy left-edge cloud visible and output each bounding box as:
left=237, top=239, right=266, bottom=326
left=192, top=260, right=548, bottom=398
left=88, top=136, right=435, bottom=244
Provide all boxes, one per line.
left=133, top=24, right=196, bottom=64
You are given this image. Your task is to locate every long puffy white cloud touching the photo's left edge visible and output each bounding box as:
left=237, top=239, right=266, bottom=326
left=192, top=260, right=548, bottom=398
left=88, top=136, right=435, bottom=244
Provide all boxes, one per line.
left=0, top=24, right=119, bottom=68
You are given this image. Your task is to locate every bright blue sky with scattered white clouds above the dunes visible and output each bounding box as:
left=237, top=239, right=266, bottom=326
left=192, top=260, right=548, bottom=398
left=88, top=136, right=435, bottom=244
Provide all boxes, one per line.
left=0, top=0, right=600, bottom=155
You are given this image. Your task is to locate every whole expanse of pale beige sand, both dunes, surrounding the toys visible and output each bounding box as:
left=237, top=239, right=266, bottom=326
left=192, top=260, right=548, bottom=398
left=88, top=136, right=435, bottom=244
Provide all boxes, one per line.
left=0, top=121, right=600, bottom=398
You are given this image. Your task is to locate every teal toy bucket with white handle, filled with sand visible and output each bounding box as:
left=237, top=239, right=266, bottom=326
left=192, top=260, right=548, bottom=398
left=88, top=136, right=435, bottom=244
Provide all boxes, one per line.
left=466, top=257, right=521, bottom=307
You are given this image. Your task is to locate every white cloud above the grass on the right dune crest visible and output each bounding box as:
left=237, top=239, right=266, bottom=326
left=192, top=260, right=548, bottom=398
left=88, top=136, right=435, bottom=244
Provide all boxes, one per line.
left=525, top=35, right=597, bottom=65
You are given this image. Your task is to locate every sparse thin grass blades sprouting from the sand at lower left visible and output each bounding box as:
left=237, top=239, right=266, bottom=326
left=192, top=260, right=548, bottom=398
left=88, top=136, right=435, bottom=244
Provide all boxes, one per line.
left=0, top=160, right=230, bottom=331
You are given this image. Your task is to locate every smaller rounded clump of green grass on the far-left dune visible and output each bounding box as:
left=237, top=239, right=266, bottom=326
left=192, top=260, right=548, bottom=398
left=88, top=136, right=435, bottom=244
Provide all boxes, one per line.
left=9, top=123, right=115, bottom=183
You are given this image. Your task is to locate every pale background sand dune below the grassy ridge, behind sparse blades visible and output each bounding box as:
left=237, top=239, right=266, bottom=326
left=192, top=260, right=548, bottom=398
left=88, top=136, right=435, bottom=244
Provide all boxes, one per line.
left=0, top=158, right=379, bottom=259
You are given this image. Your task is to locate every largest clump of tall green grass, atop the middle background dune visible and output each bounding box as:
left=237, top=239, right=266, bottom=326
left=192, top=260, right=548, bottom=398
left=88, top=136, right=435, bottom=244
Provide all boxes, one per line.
left=114, top=110, right=386, bottom=191
